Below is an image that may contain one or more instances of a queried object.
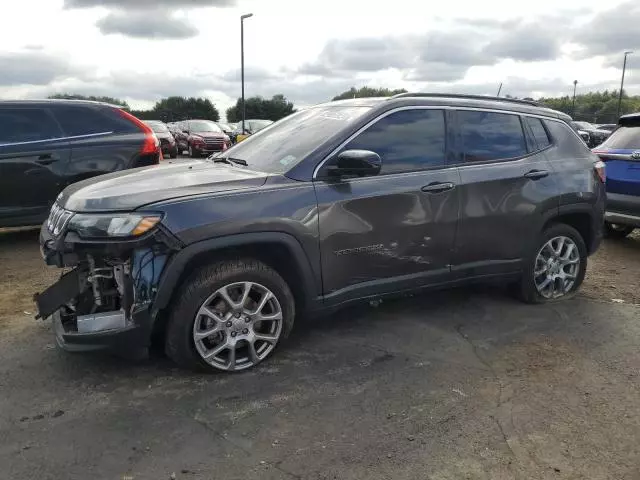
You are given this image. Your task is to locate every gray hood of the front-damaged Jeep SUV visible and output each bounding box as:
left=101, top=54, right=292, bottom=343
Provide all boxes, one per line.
left=58, top=160, right=267, bottom=212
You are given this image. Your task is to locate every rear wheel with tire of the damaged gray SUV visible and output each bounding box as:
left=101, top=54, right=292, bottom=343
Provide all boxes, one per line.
left=517, top=223, right=587, bottom=303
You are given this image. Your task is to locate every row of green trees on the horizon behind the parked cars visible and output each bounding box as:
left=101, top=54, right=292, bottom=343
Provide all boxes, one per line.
left=49, top=86, right=640, bottom=123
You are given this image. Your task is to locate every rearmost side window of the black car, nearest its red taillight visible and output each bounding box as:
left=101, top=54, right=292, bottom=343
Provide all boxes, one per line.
left=54, top=106, right=140, bottom=137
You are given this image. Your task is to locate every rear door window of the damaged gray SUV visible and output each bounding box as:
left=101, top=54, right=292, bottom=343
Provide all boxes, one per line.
left=457, top=110, right=528, bottom=163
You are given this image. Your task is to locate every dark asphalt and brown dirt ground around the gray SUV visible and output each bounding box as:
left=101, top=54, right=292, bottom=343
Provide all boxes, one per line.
left=0, top=230, right=640, bottom=480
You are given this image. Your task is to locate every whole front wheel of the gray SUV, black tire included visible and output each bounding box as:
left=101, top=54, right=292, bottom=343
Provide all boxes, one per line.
left=165, top=259, right=295, bottom=372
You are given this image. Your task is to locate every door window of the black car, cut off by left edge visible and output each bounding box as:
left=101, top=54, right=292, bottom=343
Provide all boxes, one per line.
left=0, top=108, right=63, bottom=145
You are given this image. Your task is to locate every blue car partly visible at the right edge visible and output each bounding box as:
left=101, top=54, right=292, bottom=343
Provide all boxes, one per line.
left=593, top=113, right=640, bottom=238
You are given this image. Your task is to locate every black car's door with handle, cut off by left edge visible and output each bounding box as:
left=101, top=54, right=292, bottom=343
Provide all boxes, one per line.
left=0, top=106, right=70, bottom=226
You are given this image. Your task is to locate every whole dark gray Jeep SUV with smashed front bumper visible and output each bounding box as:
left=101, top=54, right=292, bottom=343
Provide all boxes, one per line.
left=36, top=94, right=605, bottom=371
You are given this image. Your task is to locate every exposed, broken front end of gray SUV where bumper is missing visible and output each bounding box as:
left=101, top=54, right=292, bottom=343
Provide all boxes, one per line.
left=34, top=222, right=171, bottom=354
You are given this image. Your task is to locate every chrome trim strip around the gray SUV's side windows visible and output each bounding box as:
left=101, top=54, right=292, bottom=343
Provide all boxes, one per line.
left=311, top=105, right=564, bottom=181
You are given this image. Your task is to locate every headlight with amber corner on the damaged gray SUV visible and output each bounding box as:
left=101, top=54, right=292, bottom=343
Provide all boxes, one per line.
left=68, top=213, right=162, bottom=238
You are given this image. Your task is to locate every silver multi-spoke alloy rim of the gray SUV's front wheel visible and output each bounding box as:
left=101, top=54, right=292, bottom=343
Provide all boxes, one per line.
left=193, top=282, right=283, bottom=371
